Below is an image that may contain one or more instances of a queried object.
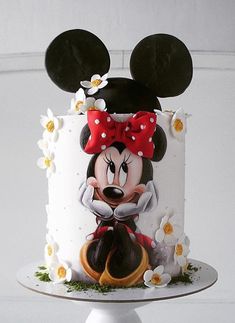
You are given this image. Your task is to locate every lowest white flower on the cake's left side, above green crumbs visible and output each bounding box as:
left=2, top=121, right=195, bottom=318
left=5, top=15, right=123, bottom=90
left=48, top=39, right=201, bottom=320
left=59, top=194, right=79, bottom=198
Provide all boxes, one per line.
left=49, top=261, right=72, bottom=283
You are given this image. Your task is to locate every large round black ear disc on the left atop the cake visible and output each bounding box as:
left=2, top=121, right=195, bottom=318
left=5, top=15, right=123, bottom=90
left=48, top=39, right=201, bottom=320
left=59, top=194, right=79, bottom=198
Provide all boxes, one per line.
left=45, top=29, right=110, bottom=92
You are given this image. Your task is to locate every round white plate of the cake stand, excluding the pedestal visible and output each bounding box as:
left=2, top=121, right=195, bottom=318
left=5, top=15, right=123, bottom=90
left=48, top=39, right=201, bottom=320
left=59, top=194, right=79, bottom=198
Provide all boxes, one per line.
left=17, top=259, right=218, bottom=303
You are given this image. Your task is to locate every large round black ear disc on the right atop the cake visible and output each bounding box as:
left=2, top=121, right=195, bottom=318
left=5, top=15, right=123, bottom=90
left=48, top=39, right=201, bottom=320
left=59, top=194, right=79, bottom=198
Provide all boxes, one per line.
left=130, top=34, right=193, bottom=97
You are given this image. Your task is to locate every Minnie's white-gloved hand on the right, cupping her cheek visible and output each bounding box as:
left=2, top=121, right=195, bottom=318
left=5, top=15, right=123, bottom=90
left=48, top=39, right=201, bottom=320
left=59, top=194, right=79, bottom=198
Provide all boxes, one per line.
left=114, top=181, right=158, bottom=220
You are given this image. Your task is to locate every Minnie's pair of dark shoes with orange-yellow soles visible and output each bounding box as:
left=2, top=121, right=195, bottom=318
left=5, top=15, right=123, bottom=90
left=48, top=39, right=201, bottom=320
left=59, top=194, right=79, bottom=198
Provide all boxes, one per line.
left=80, top=223, right=149, bottom=286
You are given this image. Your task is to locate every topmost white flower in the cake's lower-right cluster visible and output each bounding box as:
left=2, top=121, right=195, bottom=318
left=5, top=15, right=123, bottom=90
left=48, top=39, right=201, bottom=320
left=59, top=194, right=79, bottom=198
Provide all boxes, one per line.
left=155, top=210, right=182, bottom=246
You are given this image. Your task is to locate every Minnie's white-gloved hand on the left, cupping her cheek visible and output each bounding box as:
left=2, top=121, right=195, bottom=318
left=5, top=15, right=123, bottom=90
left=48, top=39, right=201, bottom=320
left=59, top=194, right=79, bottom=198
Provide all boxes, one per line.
left=78, top=182, right=113, bottom=220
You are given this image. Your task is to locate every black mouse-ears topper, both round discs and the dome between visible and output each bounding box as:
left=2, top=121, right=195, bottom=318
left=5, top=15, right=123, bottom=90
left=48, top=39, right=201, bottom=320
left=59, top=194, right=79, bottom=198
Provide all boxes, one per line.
left=46, top=29, right=192, bottom=113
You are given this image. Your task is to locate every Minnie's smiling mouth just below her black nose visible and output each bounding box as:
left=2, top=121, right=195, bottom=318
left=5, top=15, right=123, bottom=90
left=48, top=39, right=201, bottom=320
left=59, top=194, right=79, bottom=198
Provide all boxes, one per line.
left=95, top=189, right=140, bottom=208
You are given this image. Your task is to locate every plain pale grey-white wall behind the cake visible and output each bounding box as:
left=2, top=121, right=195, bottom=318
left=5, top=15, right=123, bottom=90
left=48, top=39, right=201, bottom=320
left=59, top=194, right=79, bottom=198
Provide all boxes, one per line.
left=0, top=0, right=235, bottom=323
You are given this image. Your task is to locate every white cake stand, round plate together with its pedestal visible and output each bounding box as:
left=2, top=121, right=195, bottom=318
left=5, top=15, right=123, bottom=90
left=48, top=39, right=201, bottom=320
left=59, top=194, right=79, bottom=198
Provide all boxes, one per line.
left=17, top=259, right=218, bottom=323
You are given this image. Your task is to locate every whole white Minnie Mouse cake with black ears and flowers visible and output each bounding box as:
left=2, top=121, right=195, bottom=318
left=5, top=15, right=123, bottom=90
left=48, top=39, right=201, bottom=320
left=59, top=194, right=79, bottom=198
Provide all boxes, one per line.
left=38, top=29, right=192, bottom=287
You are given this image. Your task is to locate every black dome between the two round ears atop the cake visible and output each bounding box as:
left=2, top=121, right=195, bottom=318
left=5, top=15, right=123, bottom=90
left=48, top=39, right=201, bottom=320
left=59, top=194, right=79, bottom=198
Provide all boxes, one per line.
left=93, top=77, right=161, bottom=113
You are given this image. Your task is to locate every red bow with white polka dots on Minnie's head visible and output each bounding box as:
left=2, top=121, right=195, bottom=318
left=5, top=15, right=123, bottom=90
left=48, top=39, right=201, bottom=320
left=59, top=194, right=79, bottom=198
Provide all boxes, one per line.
left=84, top=110, right=157, bottom=158
